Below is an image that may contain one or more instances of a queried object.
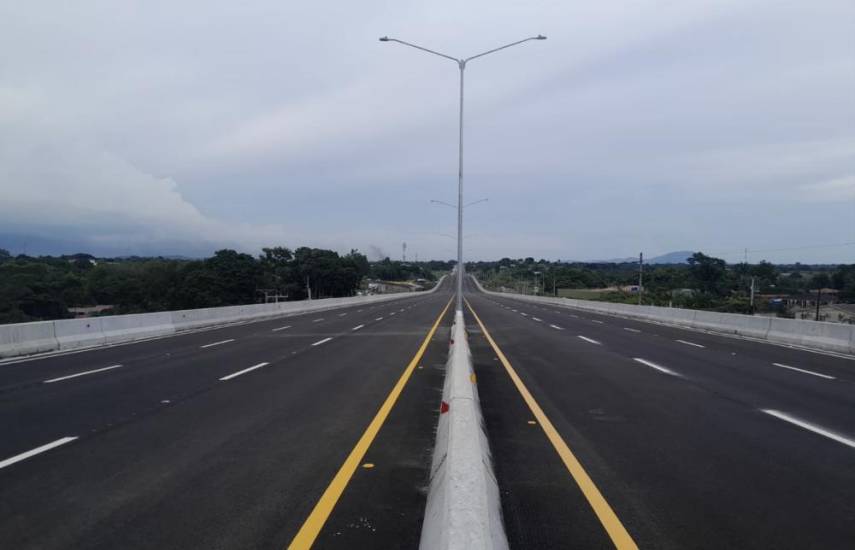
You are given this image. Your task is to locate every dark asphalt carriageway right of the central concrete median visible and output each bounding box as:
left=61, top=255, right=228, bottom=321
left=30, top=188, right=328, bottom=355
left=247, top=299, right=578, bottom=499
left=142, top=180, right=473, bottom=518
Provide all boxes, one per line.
left=467, top=282, right=855, bottom=549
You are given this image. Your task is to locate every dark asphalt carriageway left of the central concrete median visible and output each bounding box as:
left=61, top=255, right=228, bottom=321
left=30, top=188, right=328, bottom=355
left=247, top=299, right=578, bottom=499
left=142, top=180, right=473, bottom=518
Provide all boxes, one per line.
left=0, top=282, right=452, bottom=549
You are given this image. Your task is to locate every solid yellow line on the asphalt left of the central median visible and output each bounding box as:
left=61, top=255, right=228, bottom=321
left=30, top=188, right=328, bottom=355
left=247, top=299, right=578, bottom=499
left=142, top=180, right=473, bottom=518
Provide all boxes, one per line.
left=288, top=300, right=451, bottom=549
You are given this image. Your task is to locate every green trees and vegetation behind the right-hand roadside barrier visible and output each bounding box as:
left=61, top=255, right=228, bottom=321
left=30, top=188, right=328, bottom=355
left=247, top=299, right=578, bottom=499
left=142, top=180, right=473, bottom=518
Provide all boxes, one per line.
left=469, top=252, right=855, bottom=316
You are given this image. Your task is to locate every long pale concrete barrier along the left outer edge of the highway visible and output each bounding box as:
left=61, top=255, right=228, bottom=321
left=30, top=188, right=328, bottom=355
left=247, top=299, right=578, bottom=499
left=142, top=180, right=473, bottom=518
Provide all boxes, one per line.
left=0, top=276, right=445, bottom=358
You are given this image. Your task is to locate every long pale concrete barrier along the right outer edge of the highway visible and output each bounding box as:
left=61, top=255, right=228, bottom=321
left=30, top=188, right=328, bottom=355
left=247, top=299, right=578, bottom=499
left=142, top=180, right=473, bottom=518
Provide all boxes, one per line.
left=472, top=277, right=855, bottom=355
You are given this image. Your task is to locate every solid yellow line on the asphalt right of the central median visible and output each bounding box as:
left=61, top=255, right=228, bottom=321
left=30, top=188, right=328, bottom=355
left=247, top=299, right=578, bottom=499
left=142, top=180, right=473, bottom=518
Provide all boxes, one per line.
left=466, top=300, right=638, bottom=550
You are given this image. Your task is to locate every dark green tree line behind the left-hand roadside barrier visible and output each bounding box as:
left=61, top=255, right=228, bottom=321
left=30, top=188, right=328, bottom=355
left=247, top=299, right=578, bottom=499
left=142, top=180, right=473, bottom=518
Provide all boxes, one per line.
left=0, top=247, right=450, bottom=323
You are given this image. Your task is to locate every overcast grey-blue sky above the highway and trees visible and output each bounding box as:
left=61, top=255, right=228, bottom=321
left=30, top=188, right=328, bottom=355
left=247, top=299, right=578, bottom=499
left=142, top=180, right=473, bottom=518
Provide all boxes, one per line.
left=0, top=0, right=855, bottom=263
